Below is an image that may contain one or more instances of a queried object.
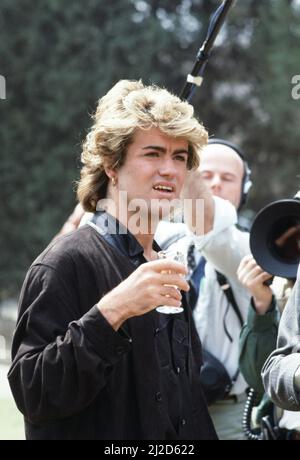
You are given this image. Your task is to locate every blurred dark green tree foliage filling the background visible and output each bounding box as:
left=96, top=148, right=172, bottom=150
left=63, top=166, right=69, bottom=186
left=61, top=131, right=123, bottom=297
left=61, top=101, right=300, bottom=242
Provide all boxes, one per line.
left=0, top=0, right=300, bottom=297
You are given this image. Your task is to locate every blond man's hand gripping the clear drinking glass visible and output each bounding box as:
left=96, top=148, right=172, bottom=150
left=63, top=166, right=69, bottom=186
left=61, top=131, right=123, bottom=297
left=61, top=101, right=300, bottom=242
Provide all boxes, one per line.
left=98, top=259, right=189, bottom=330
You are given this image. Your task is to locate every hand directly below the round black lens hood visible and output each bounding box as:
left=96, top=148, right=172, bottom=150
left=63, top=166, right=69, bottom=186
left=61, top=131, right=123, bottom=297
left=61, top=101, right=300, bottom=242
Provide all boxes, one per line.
left=237, top=255, right=273, bottom=315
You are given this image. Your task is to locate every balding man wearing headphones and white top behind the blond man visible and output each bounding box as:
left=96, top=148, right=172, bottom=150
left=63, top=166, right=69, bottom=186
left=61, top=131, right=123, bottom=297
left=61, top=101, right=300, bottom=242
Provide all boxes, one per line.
left=155, top=139, right=252, bottom=440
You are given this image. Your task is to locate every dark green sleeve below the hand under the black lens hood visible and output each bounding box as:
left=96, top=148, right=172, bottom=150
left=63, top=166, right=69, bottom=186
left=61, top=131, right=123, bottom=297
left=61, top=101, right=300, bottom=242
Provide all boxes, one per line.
left=239, top=297, right=278, bottom=396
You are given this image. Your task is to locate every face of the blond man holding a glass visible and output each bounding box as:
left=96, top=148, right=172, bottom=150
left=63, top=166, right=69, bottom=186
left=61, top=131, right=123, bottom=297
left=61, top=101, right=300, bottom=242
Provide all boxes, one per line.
left=117, top=128, right=189, bottom=219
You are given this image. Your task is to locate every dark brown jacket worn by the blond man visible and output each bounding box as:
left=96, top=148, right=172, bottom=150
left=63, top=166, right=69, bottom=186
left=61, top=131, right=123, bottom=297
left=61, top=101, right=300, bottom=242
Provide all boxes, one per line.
left=9, top=225, right=216, bottom=440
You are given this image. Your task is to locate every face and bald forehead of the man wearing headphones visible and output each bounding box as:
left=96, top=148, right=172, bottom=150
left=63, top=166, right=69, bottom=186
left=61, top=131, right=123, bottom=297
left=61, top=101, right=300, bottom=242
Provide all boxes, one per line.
left=199, top=144, right=244, bottom=208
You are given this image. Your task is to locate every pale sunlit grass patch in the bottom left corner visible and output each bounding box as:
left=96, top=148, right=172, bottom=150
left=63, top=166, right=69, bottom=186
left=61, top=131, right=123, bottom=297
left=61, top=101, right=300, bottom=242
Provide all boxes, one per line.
left=0, top=398, right=25, bottom=441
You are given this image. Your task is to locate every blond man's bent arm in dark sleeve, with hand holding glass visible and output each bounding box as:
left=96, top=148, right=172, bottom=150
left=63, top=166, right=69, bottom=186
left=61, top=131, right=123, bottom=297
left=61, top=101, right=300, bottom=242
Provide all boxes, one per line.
left=8, top=255, right=189, bottom=423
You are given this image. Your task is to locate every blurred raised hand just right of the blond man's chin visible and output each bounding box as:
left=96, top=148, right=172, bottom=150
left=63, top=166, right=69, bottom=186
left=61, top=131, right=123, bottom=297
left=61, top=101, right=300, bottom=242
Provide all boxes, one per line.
left=181, top=169, right=215, bottom=236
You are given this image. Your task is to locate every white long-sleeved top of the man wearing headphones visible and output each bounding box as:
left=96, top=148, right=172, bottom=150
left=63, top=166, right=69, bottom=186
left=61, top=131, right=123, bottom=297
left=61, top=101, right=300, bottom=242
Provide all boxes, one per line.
left=155, top=197, right=250, bottom=395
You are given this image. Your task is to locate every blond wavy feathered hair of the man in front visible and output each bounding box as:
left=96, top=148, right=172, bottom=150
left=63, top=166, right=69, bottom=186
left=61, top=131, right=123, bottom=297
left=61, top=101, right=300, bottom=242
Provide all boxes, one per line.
left=77, top=80, right=208, bottom=212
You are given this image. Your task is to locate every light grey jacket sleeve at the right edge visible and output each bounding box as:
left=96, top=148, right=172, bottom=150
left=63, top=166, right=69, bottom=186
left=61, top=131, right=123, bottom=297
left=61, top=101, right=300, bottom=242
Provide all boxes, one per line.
left=262, top=270, right=300, bottom=411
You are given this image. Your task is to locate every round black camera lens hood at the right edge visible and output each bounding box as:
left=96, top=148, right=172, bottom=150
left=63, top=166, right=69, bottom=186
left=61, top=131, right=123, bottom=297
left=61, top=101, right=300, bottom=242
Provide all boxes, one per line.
left=250, top=192, right=300, bottom=278
